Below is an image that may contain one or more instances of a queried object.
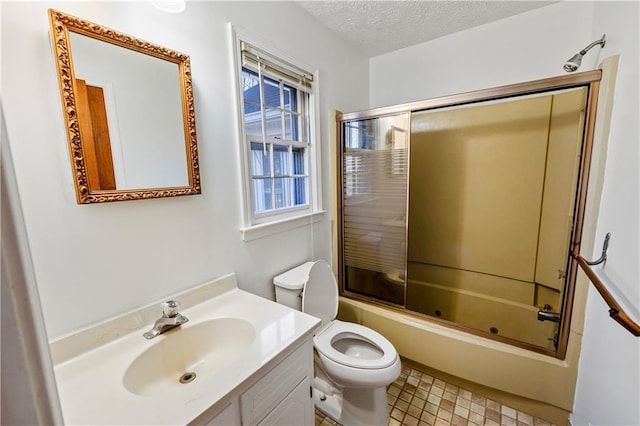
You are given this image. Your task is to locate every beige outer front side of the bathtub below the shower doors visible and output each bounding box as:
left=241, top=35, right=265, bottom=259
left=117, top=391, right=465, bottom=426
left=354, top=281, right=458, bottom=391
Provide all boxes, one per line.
left=338, top=296, right=582, bottom=425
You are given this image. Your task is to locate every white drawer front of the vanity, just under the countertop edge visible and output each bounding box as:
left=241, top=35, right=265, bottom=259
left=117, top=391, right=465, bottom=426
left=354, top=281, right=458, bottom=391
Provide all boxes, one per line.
left=240, top=341, right=313, bottom=425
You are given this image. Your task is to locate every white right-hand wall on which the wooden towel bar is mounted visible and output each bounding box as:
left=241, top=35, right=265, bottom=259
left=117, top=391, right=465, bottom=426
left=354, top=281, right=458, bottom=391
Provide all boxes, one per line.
left=572, top=1, right=640, bottom=426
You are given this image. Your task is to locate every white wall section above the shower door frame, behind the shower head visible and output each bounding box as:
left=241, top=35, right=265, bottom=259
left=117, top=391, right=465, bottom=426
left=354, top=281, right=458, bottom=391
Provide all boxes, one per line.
left=369, top=2, right=599, bottom=108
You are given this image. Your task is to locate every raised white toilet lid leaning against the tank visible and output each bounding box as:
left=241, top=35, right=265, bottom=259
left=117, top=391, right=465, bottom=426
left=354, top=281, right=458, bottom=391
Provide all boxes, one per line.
left=302, top=260, right=338, bottom=324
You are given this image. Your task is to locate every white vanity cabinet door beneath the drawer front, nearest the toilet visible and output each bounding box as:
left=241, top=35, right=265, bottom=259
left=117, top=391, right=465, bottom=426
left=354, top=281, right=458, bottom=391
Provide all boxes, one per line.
left=258, top=377, right=315, bottom=426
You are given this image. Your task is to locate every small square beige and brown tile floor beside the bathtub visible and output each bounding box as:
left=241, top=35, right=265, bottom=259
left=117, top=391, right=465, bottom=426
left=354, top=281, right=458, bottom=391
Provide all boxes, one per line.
left=315, top=365, right=551, bottom=426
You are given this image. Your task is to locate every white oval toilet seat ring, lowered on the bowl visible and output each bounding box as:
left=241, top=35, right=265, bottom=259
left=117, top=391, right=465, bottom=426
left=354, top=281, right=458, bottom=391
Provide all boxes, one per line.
left=313, top=320, right=398, bottom=370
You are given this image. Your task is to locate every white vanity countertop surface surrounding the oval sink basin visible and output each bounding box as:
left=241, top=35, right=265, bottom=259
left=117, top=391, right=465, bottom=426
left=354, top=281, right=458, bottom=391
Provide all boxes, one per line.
left=54, top=278, right=320, bottom=425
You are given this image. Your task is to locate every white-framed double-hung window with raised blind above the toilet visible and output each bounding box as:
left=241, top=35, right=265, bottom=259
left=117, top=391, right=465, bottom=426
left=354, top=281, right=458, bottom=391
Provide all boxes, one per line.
left=239, top=41, right=315, bottom=230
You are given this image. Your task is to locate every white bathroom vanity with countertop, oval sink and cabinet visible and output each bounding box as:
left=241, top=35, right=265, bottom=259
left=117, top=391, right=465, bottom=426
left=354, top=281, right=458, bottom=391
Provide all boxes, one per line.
left=51, top=274, right=320, bottom=425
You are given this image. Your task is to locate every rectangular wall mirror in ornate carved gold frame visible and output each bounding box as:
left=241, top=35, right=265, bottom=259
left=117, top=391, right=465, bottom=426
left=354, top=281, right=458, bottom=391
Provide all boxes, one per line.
left=49, top=9, right=201, bottom=204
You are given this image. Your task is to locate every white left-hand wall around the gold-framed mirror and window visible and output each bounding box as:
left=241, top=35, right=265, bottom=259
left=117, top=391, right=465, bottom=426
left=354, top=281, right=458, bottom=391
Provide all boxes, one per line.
left=0, top=2, right=368, bottom=338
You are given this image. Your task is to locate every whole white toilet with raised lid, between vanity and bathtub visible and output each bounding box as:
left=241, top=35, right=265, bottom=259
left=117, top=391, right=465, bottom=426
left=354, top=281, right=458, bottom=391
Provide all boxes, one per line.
left=273, top=260, right=400, bottom=425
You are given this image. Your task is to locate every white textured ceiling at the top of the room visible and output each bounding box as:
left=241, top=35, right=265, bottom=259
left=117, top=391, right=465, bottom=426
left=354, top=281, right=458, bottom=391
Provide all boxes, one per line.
left=297, top=0, right=554, bottom=57
